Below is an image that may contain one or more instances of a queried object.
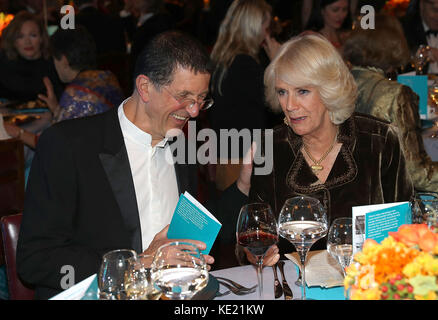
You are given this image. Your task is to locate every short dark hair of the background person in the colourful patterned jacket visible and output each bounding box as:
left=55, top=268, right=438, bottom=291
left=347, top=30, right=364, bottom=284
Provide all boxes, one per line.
left=50, top=25, right=97, bottom=71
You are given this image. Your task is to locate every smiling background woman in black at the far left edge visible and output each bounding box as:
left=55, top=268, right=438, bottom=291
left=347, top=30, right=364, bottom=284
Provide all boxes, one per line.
left=0, top=11, right=62, bottom=101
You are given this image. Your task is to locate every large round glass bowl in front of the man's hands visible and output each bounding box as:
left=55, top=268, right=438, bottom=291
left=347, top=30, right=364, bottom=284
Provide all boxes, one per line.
left=151, top=241, right=208, bottom=300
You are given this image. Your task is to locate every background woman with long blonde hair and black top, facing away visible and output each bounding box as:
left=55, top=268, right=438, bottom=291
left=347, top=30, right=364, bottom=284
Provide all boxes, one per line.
left=209, top=0, right=279, bottom=190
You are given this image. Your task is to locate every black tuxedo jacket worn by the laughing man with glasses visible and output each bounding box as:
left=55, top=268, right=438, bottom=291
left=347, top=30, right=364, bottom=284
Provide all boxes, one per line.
left=17, top=108, right=247, bottom=299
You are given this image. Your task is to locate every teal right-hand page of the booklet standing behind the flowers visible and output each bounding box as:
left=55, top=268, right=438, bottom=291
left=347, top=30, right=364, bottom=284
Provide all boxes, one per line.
left=365, top=203, right=412, bottom=243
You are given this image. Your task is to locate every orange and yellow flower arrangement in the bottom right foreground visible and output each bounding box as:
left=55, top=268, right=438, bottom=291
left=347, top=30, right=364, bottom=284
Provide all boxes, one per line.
left=344, top=224, right=438, bottom=300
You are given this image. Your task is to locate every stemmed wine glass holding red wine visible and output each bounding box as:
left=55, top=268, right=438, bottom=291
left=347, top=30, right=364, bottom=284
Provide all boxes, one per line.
left=236, top=203, right=278, bottom=299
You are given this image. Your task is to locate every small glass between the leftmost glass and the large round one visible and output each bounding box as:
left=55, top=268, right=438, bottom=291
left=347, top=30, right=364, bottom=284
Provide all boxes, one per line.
left=125, top=254, right=161, bottom=300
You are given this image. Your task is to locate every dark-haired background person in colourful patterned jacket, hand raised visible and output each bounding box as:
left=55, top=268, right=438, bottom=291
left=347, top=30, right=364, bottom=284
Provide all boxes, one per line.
left=5, top=26, right=124, bottom=148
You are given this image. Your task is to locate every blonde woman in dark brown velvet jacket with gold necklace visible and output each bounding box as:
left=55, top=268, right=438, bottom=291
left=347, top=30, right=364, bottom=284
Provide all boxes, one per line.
left=249, top=35, right=414, bottom=254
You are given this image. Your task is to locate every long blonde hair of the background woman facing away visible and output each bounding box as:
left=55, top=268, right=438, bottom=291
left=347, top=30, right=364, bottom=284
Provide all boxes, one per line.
left=210, top=0, right=272, bottom=93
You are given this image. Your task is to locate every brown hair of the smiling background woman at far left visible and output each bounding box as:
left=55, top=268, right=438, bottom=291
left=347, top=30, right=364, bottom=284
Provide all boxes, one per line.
left=1, top=11, right=49, bottom=60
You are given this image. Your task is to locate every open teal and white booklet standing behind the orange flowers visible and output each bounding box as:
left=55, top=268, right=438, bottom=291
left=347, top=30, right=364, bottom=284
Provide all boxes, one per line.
left=353, top=202, right=412, bottom=252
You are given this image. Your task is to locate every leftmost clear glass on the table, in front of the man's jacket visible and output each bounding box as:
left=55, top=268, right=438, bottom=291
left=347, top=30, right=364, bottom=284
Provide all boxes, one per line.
left=98, top=249, right=137, bottom=300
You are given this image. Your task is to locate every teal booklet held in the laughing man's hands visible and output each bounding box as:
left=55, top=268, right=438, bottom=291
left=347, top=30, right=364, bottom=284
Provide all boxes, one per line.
left=167, top=191, right=222, bottom=254
